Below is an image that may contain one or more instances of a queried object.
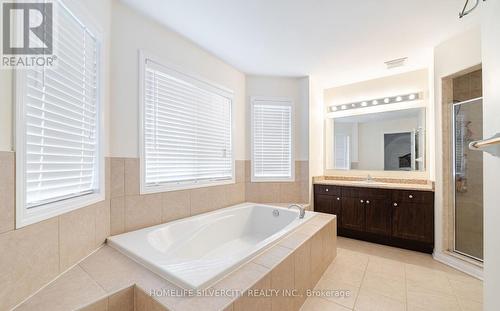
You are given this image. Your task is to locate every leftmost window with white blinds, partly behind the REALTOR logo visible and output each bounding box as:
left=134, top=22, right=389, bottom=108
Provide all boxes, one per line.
left=16, top=3, right=104, bottom=227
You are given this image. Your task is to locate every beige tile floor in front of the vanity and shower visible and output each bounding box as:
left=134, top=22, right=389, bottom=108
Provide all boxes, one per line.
left=301, top=238, right=483, bottom=311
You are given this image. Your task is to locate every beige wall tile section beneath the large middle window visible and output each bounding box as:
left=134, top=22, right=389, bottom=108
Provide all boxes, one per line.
left=111, top=158, right=248, bottom=235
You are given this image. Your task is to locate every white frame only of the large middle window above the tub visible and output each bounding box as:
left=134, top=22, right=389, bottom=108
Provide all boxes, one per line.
left=138, top=50, right=236, bottom=194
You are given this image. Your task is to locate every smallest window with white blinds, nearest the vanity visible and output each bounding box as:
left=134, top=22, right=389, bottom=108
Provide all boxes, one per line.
left=252, top=98, right=295, bottom=181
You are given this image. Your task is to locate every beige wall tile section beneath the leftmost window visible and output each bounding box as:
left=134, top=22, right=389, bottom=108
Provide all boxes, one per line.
left=0, top=152, right=110, bottom=310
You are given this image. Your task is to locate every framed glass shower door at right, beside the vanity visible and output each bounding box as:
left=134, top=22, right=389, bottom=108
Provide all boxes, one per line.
left=453, top=98, right=483, bottom=261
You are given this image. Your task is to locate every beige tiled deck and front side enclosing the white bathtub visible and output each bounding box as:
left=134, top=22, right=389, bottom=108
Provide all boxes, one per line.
left=16, top=214, right=337, bottom=311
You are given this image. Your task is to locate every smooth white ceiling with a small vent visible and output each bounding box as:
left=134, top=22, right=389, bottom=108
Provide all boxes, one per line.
left=122, top=0, right=480, bottom=87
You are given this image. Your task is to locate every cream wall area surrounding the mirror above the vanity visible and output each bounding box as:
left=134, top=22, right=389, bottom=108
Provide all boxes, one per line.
left=323, top=69, right=433, bottom=179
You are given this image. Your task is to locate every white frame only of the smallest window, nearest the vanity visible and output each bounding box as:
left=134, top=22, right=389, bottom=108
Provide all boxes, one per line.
left=250, top=96, right=295, bottom=182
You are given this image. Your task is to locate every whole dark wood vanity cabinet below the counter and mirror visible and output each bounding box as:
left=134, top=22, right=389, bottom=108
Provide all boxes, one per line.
left=314, top=185, right=434, bottom=253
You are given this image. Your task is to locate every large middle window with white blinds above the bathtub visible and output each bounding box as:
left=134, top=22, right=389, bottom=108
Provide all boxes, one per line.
left=140, top=55, right=234, bottom=193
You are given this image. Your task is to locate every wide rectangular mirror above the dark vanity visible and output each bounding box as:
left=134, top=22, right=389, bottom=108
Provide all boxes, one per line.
left=331, top=108, right=425, bottom=171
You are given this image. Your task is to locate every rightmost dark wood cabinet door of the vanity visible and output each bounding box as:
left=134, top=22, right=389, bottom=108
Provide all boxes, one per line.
left=392, top=202, right=434, bottom=242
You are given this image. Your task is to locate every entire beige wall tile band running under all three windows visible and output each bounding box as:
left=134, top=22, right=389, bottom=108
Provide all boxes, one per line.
left=0, top=152, right=308, bottom=310
